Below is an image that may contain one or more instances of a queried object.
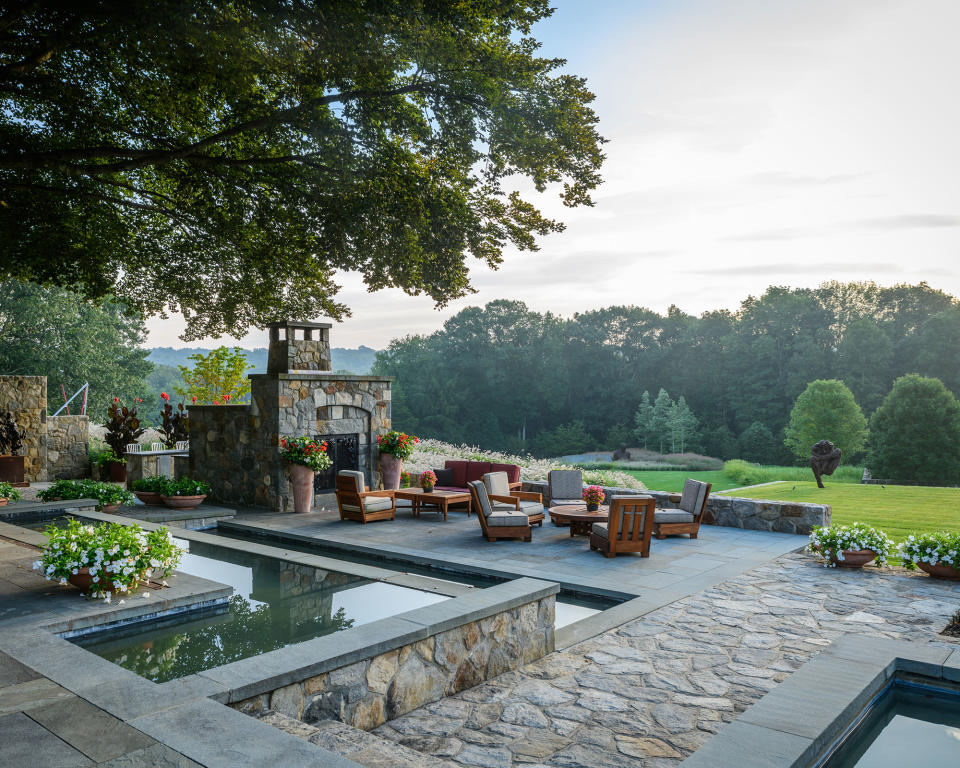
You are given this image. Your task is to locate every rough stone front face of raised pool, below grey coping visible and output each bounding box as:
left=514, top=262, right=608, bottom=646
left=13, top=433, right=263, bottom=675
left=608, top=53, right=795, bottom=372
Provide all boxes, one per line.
left=230, top=595, right=555, bottom=730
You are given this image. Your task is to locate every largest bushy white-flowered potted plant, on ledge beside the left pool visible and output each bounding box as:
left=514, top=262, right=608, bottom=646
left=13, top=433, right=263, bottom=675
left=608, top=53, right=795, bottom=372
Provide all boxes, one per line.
left=33, top=519, right=183, bottom=602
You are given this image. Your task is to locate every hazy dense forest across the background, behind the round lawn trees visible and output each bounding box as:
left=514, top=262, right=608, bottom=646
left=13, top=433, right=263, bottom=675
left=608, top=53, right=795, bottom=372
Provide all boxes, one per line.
left=373, top=282, right=960, bottom=463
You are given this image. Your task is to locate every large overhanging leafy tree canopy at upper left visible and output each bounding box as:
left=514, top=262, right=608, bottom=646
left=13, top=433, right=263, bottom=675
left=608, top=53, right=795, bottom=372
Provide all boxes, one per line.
left=0, top=0, right=603, bottom=338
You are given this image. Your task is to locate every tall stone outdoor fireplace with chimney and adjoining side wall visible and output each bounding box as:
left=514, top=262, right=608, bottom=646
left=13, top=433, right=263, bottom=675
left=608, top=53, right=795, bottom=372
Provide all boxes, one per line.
left=190, top=321, right=391, bottom=512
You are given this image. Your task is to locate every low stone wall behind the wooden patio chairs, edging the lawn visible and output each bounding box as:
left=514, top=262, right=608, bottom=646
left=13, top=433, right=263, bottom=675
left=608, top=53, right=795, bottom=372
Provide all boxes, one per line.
left=523, top=481, right=833, bottom=535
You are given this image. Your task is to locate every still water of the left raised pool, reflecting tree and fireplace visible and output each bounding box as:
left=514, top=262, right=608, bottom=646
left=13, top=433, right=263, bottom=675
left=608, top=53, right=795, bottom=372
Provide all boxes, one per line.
left=76, top=542, right=446, bottom=682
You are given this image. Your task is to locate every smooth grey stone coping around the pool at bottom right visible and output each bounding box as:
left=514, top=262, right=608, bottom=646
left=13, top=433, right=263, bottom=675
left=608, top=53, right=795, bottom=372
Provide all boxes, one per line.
left=681, top=636, right=960, bottom=768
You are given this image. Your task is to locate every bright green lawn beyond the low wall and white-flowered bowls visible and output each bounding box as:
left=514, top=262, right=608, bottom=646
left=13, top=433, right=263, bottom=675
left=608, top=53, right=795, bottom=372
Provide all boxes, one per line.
left=724, top=472, right=960, bottom=542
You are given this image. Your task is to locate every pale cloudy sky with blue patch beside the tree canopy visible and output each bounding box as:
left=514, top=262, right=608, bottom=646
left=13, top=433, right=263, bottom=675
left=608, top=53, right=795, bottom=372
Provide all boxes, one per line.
left=147, top=0, right=960, bottom=349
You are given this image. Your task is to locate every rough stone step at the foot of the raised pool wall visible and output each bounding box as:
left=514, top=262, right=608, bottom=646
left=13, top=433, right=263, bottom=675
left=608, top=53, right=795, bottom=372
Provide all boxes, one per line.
left=259, top=710, right=462, bottom=768
